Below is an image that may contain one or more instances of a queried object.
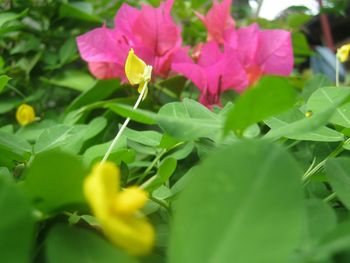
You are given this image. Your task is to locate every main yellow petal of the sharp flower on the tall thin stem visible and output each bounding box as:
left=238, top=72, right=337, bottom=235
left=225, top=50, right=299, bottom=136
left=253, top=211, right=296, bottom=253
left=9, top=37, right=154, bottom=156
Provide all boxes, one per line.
left=125, top=49, right=147, bottom=85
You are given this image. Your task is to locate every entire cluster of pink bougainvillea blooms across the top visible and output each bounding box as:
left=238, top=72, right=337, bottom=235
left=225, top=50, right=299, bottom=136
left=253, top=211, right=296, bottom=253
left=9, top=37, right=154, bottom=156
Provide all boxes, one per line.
left=77, top=0, right=293, bottom=107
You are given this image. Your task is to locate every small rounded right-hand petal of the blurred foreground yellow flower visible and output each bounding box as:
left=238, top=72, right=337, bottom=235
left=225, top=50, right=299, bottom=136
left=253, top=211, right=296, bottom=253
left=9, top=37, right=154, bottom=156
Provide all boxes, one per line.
left=114, top=186, right=148, bottom=215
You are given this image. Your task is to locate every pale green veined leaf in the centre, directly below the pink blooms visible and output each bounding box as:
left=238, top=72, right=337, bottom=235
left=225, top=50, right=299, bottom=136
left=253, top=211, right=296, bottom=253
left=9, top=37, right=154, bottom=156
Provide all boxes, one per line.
left=156, top=99, right=223, bottom=140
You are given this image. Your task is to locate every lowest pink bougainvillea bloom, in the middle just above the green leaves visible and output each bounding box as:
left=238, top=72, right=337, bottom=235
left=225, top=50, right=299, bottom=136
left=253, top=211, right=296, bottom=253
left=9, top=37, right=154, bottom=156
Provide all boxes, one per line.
left=172, top=41, right=248, bottom=108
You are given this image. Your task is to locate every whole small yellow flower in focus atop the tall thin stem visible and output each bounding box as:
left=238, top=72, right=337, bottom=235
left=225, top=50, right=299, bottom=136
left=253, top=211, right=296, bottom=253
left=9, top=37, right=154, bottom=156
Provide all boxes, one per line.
left=125, top=49, right=152, bottom=98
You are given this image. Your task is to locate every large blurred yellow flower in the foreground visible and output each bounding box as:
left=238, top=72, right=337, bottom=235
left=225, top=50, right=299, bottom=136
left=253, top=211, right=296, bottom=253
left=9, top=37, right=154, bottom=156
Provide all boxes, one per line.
left=84, top=161, right=155, bottom=255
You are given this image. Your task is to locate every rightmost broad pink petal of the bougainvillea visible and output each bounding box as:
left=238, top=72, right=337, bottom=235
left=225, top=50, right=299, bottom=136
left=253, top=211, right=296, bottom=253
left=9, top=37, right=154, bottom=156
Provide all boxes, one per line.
left=256, top=30, right=294, bottom=76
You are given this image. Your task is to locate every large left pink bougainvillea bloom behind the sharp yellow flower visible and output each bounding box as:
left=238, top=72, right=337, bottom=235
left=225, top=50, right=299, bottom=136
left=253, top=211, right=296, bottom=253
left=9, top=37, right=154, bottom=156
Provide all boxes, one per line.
left=77, top=0, right=182, bottom=81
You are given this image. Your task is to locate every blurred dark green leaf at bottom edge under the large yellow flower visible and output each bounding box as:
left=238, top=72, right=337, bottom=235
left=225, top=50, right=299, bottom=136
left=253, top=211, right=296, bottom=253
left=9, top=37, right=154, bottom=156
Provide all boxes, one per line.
left=46, top=225, right=137, bottom=263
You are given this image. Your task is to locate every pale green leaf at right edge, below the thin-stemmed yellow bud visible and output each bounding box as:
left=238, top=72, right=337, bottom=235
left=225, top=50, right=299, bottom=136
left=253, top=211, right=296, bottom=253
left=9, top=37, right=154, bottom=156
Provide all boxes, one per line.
left=307, top=87, right=350, bottom=128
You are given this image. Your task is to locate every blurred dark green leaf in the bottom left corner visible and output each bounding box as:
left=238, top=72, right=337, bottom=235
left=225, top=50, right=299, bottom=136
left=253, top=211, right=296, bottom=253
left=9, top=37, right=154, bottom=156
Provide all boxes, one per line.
left=0, top=176, right=34, bottom=263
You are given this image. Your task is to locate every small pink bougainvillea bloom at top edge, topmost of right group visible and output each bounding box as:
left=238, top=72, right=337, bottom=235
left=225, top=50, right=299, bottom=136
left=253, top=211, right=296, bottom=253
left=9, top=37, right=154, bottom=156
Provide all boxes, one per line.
left=196, top=0, right=235, bottom=44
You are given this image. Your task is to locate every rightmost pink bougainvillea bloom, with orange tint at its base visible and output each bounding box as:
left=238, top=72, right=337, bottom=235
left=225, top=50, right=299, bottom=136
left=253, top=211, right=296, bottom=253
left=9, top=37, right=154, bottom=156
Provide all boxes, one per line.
left=225, top=24, right=294, bottom=85
